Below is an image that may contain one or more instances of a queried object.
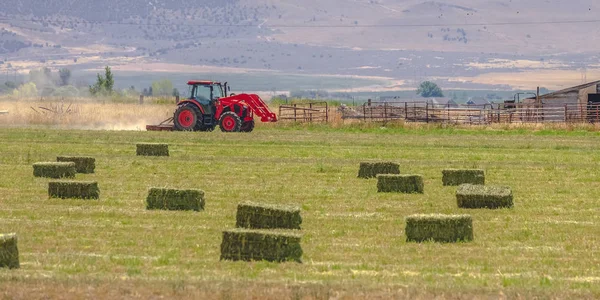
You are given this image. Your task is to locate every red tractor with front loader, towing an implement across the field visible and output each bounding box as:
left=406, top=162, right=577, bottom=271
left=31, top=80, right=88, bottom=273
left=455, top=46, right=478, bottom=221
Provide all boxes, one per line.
left=146, top=80, right=277, bottom=132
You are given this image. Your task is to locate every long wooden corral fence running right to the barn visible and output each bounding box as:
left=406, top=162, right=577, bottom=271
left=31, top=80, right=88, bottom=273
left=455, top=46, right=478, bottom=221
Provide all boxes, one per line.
left=341, top=102, right=600, bottom=125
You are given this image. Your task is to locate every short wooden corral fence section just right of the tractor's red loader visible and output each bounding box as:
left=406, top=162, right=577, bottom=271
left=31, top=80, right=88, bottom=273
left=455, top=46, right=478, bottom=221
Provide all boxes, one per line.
left=277, top=101, right=329, bottom=123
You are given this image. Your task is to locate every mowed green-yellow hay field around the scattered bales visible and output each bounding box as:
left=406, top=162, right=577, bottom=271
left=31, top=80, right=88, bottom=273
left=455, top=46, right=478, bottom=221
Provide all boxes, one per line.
left=0, top=126, right=600, bottom=299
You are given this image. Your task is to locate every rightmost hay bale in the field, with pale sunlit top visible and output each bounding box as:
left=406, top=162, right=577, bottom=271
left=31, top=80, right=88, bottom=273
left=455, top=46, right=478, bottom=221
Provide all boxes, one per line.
left=456, top=184, right=513, bottom=209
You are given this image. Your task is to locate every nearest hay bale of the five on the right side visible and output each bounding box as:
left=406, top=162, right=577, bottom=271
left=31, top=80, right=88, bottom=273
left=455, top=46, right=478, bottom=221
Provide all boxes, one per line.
left=405, top=214, right=473, bottom=243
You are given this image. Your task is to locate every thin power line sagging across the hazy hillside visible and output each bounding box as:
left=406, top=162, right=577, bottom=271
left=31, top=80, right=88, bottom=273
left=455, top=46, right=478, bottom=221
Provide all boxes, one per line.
left=0, top=17, right=600, bottom=28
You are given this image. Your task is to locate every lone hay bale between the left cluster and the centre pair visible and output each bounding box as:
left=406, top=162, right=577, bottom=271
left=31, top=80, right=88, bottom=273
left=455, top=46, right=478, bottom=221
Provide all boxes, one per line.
left=146, top=188, right=204, bottom=211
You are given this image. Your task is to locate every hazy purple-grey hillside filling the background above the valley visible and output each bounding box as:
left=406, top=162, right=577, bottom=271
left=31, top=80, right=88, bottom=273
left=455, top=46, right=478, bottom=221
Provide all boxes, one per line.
left=0, top=0, right=600, bottom=88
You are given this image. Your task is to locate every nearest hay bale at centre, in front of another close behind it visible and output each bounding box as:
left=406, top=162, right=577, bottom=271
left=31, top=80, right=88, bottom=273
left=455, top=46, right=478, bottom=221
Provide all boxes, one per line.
left=221, top=229, right=302, bottom=263
